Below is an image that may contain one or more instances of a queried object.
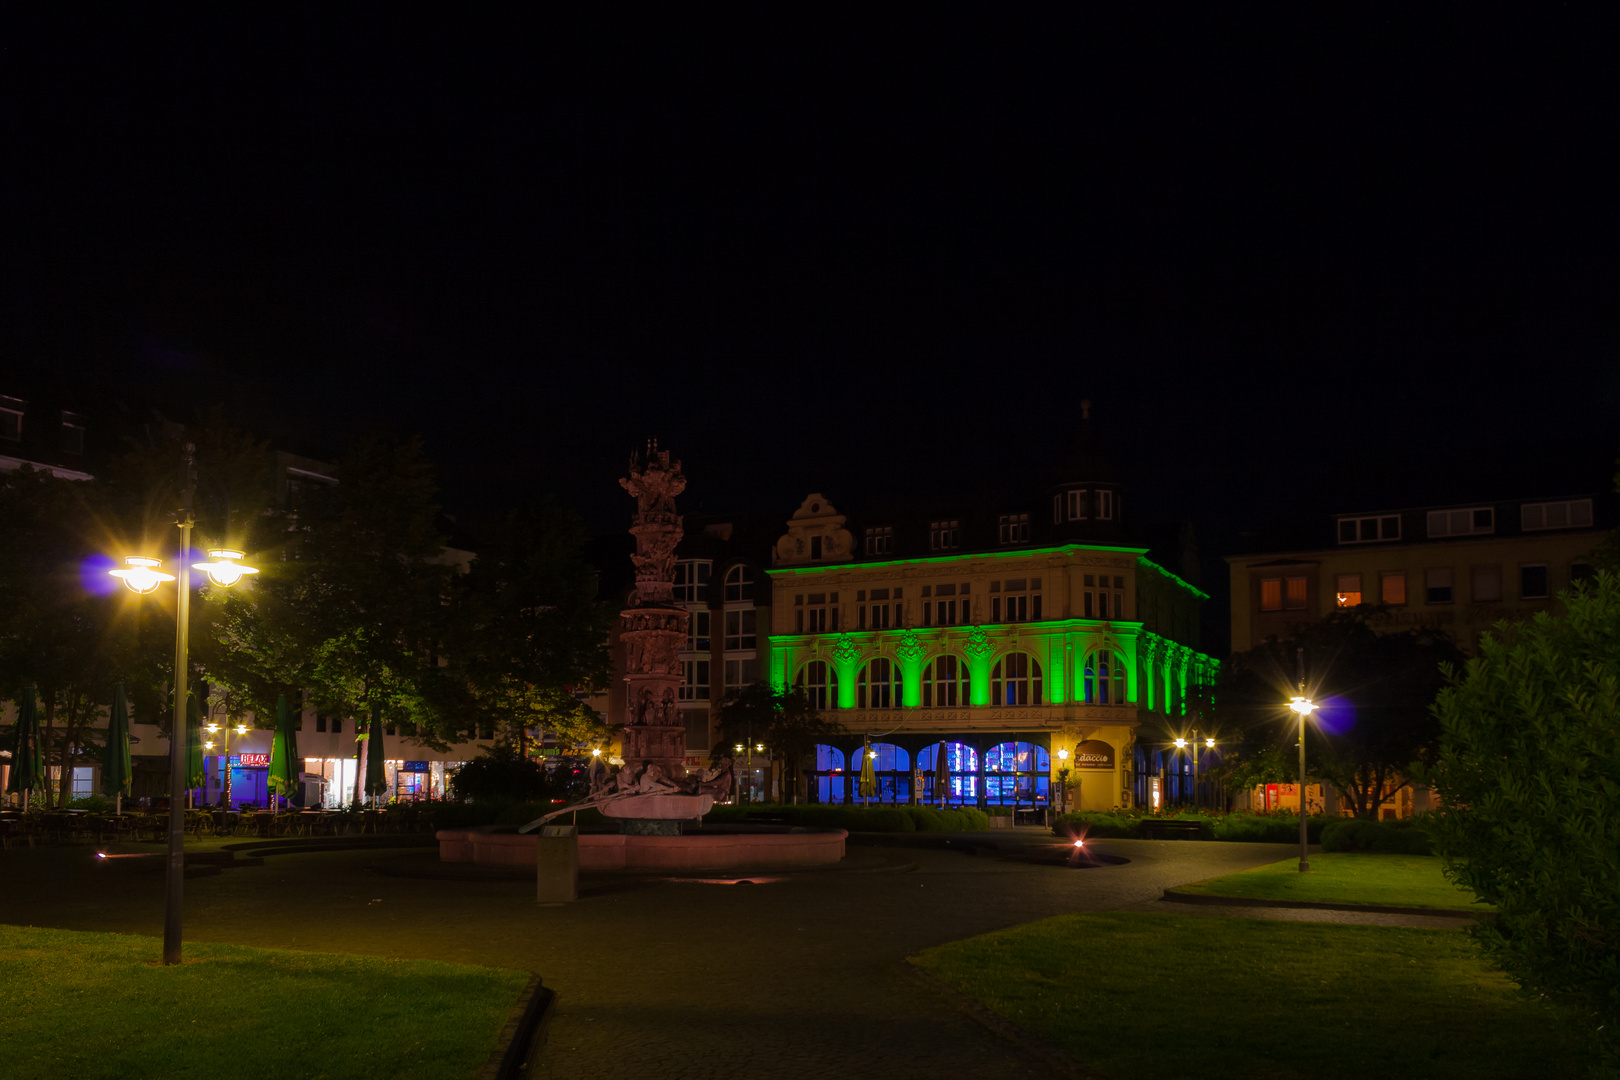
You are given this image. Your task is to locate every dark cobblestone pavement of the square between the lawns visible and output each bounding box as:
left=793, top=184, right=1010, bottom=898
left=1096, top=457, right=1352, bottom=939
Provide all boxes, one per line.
left=0, top=831, right=1289, bottom=1080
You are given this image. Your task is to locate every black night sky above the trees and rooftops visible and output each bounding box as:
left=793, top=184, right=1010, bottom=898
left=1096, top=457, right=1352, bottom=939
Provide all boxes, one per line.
left=0, top=3, right=1620, bottom=573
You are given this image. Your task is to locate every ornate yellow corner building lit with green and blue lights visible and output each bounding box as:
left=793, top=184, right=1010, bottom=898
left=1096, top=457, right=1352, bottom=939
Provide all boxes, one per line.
left=768, top=470, right=1215, bottom=816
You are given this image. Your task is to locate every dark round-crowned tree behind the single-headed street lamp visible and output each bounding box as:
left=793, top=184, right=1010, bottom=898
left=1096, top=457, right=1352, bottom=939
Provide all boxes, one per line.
left=1210, top=610, right=1463, bottom=818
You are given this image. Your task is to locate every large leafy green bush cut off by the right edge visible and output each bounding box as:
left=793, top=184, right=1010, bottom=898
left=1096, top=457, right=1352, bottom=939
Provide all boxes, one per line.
left=1426, top=572, right=1620, bottom=1061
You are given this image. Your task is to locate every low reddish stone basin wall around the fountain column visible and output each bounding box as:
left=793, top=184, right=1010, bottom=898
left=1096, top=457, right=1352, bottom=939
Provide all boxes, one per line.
left=437, top=827, right=849, bottom=870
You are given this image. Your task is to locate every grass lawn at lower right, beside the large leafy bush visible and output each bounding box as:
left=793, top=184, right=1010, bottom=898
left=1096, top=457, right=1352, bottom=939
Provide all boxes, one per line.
left=912, top=912, right=1586, bottom=1080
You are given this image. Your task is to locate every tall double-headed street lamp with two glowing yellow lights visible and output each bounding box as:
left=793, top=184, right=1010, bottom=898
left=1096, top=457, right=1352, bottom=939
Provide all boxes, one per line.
left=110, top=442, right=258, bottom=965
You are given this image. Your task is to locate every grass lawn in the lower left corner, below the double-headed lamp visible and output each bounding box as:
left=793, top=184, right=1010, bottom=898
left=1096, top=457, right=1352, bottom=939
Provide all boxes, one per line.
left=0, top=926, right=528, bottom=1080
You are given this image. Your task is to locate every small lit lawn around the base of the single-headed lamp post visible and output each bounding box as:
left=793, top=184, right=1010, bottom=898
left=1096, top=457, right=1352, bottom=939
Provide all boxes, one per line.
left=1176, top=852, right=1495, bottom=912
